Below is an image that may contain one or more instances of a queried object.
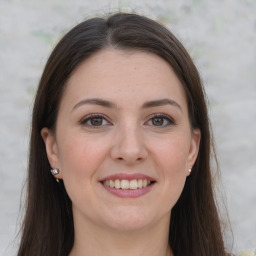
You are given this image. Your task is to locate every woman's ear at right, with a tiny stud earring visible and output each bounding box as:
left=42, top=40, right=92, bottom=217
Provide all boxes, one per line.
left=187, top=129, right=201, bottom=174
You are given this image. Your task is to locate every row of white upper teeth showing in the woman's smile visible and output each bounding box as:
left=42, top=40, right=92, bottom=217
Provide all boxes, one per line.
left=103, top=179, right=151, bottom=189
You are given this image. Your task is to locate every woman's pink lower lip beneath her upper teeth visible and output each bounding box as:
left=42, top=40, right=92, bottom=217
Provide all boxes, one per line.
left=101, top=183, right=155, bottom=198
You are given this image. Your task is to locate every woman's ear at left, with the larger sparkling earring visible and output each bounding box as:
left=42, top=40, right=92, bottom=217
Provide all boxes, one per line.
left=41, top=128, right=62, bottom=179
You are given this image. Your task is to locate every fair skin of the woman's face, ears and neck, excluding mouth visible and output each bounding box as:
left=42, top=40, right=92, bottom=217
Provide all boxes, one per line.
left=41, top=49, right=200, bottom=256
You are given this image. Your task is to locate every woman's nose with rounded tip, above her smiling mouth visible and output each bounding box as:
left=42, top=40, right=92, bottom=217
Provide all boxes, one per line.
left=110, top=127, right=148, bottom=165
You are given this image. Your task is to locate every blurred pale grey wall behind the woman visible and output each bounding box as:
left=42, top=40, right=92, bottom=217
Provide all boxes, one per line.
left=0, top=0, right=256, bottom=256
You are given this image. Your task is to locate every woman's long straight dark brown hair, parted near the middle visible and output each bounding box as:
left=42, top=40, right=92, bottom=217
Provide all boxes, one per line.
left=18, top=13, right=230, bottom=256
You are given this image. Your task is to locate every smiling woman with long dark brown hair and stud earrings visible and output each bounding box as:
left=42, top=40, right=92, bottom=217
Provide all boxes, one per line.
left=18, top=13, right=232, bottom=256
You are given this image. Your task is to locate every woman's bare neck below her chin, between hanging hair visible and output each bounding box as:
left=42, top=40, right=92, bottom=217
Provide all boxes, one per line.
left=69, top=213, right=173, bottom=256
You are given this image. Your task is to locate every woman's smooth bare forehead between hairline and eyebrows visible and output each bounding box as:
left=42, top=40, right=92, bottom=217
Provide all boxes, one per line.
left=62, top=49, right=186, bottom=110
